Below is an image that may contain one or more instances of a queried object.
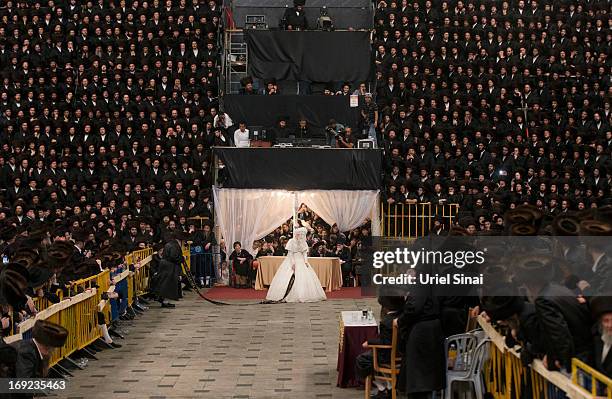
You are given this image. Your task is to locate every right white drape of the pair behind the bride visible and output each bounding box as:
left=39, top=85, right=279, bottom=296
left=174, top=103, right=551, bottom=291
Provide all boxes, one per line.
left=298, top=190, right=378, bottom=231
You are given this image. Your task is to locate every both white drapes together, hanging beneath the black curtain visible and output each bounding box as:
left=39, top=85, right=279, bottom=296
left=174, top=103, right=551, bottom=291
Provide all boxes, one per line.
left=213, top=187, right=380, bottom=255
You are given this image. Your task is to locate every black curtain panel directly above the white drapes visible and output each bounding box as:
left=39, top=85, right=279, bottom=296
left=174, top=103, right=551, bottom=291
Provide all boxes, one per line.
left=214, top=147, right=382, bottom=190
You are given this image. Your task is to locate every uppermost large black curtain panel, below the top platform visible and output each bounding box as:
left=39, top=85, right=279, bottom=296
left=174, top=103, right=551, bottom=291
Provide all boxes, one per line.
left=246, top=30, right=372, bottom=82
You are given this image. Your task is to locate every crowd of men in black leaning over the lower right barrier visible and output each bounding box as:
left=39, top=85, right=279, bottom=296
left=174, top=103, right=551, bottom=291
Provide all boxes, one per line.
left=357, top=205, right=612, bottom=399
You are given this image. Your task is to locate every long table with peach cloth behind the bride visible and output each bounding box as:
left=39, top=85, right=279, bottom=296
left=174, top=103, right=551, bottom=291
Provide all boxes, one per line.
left=255, top=256, right=342, bottom=292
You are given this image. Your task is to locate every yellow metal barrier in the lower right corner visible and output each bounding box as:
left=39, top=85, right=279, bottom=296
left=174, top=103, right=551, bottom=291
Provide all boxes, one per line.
left=478, top=317, right=596, bottom=399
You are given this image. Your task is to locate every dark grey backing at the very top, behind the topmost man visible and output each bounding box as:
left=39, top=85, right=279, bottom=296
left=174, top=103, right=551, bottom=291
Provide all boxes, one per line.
left=226, top=0, right=374, bottom=29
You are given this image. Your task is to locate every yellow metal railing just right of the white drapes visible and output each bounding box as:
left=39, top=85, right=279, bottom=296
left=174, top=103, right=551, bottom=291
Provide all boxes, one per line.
left=380, top=202, right=459, bottom=239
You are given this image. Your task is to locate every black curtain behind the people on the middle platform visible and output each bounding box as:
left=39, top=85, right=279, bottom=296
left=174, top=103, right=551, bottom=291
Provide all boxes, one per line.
left=224, top=94, right=359, bottom=137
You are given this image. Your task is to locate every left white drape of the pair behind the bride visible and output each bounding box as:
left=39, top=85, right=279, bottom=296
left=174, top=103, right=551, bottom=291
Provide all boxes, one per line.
left=213, top=187, right=294, bottom=255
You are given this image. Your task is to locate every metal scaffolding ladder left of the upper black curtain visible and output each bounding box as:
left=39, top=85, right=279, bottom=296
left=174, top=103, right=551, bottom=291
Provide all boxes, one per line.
left=223, top=29, right=249, bottom=94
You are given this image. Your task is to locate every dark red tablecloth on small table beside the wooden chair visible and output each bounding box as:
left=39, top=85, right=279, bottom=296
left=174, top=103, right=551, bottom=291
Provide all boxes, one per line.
left=337, top=320, right=378, bottom=388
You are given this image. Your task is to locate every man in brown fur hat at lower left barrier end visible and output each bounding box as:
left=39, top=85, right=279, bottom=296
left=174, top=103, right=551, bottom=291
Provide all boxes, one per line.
left=15, top=320, right=68, bottom=378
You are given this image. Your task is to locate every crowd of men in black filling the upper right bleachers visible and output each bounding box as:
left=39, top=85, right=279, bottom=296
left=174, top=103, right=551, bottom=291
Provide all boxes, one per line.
left=370, top=0, right=612, bottom=230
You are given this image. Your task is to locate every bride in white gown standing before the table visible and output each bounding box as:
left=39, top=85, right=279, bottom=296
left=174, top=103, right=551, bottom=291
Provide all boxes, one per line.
left=266, top=227, right=327, bottom=302
